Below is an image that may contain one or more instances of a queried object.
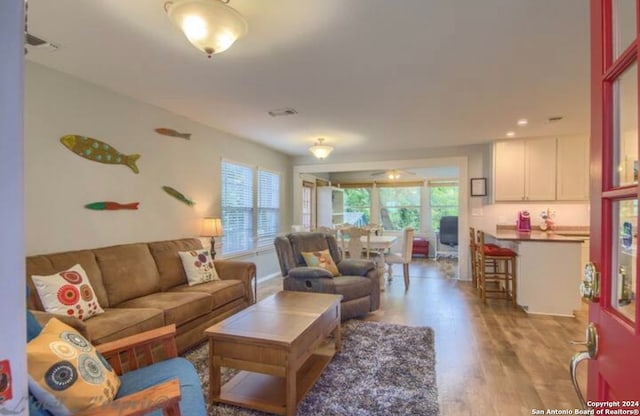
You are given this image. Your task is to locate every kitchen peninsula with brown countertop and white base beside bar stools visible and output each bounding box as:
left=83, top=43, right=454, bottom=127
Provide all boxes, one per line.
left=485, top=226, right=589, bottom=316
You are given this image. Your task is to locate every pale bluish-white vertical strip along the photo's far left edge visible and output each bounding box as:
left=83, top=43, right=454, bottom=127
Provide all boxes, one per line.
left=0, top=0, right=27, bottom=415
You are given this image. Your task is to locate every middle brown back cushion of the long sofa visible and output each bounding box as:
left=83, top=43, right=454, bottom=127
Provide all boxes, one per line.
left=94, top=243, right=161, bottom=306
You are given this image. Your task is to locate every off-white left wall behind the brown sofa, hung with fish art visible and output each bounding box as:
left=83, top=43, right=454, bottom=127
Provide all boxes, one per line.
left=25, top=63, right=292, bottom=276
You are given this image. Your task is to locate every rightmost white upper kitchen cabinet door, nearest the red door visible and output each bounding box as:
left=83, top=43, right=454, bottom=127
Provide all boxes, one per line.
left=557, top=136, right=589, bottom=201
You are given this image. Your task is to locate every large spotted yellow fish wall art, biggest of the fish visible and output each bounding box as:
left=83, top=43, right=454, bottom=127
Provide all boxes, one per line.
left=60, top=134, right=140, bottom=173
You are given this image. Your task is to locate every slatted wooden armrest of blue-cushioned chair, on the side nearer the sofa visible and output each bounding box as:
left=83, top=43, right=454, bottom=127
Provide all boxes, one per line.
left=96, top=324, right=178, bottom=375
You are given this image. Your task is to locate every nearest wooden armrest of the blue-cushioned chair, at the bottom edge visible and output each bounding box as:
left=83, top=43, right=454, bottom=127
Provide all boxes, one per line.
left=74, top=379, right=181, bottom=416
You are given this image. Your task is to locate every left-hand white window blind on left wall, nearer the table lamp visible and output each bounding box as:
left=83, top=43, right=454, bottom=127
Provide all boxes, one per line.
left=222, top=161, right=253, bottom=255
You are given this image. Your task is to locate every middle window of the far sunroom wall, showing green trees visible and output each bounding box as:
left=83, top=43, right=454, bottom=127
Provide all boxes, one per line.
left=380, top=186, right=422, bottom=231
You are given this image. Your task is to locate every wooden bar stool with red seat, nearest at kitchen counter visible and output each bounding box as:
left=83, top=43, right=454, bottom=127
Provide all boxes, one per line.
left=477, top=231, right=518, bottom=308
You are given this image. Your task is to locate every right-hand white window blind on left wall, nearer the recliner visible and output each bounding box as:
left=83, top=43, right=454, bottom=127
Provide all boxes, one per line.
left=257, top=170, right=280, bottom=247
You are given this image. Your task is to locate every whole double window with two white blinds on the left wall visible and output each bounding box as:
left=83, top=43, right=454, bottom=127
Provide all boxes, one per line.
left=221, top=161, right=280, bottom=254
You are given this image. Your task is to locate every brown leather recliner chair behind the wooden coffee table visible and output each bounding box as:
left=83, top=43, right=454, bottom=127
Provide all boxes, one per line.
left=274, top=232, right=380, bottom=320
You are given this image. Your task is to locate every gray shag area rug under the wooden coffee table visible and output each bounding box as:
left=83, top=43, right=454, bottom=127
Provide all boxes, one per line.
left=184, top=320, right=439, bottom=416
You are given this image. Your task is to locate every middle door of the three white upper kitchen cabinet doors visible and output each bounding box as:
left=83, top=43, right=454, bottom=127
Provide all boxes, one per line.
left=524, top=137, right=556, bottom=201
